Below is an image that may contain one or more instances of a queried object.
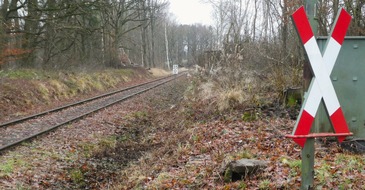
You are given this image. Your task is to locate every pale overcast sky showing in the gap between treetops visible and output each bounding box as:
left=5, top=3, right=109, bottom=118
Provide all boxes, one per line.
left=169, top=0, right=212, bottom=25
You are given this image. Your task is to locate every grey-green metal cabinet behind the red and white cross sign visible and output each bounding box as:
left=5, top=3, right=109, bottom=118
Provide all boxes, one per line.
left=312, top=36, right=365, bottom=140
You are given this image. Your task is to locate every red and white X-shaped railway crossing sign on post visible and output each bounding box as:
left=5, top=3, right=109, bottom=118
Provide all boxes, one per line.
left=291, top=7, right=351, bottom=147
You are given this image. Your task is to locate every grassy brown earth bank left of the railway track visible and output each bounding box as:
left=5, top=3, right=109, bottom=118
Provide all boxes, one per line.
left=0, top=67, right=164, bottom=122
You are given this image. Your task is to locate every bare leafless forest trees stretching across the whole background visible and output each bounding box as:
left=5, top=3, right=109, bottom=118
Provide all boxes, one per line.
left=0, top=0, right=365, bottom=72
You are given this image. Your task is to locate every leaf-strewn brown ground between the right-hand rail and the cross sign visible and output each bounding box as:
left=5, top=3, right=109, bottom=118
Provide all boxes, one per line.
left=0, top=74, right=365, bottom=189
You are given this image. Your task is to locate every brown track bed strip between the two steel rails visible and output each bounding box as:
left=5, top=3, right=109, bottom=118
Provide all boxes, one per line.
left=0, top=73, right=186, bottom=151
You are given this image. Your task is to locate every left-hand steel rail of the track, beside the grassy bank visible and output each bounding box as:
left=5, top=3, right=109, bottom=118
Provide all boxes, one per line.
left=0, top=73, right=171, bottom=127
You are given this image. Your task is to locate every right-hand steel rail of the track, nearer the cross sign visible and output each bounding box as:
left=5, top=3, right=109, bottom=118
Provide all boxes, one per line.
left=0, top=72, right=186, bottom=152
